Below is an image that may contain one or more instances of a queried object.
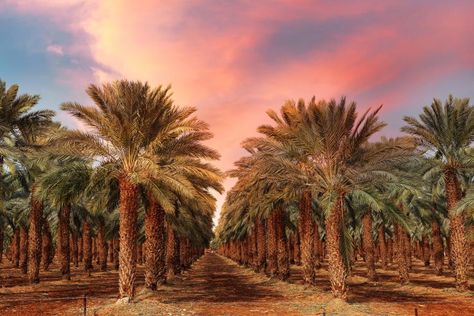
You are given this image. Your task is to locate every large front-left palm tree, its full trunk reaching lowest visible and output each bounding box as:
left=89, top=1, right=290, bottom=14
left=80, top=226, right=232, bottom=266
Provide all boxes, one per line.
left=57, top=81, right=217, bottom=301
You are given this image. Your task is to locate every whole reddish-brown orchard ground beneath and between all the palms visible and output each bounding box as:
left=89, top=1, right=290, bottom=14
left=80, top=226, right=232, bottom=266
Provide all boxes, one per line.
left=0, top=253, right=474, bottom=316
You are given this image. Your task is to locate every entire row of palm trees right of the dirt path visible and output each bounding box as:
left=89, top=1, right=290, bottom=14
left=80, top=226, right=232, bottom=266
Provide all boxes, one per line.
left=214, top=96, right=474, bottom=299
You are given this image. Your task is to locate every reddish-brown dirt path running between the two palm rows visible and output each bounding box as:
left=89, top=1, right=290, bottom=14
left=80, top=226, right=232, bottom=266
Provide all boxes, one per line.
left=151, top=253, right=308, bottom=315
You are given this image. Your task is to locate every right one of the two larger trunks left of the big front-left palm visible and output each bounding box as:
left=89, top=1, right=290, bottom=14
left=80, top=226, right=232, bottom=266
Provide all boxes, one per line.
left=58, top=205, right=71, bottom=280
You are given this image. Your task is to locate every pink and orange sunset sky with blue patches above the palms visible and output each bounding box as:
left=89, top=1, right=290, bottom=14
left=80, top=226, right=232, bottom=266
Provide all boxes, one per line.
left=0, top=0, right=474, bottom=222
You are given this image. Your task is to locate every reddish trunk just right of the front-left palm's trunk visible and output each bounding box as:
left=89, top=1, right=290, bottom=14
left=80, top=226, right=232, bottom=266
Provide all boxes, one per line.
left=145, top=195, right=166, bottom=290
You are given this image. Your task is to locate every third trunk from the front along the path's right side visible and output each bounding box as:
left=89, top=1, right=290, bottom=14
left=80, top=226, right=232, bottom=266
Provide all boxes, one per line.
left=273, top=206, right=290, bottom=280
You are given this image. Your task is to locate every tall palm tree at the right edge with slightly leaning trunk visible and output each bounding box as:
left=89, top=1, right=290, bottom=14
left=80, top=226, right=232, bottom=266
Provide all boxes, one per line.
left=402, top=96, right=474, bottom=291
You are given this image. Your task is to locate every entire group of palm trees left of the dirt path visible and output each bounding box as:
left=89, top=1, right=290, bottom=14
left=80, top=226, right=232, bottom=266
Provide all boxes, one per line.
left=0, top=81, right=223, bottom=301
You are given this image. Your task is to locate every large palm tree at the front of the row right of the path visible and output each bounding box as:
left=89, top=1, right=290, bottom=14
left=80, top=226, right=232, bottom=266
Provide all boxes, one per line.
left=248, top=98, right=406, bottom=298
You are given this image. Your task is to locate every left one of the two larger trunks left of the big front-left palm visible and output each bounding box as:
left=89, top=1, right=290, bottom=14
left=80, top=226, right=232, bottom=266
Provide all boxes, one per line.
left=28, top=191, right=43, bottom=283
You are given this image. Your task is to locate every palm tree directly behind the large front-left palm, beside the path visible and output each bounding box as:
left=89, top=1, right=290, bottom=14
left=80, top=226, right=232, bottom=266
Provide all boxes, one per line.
left=145, top=118, right=223, bottom=290
